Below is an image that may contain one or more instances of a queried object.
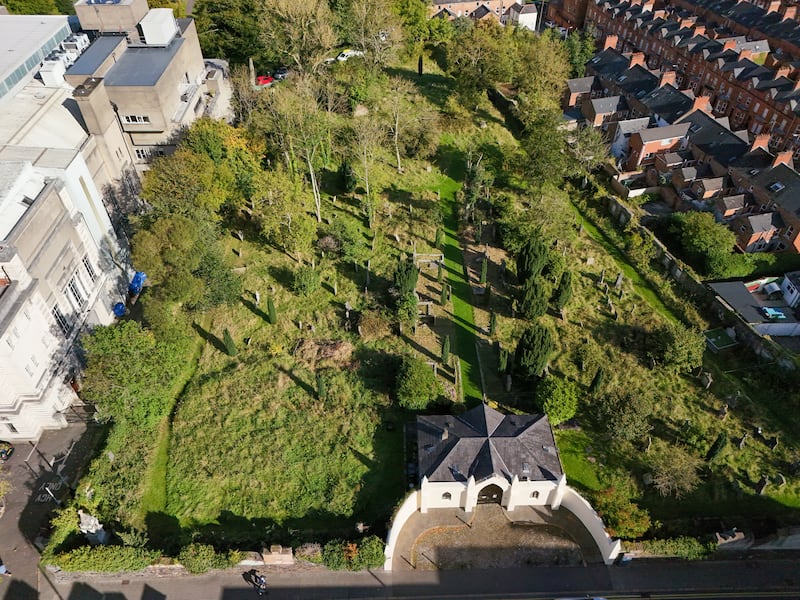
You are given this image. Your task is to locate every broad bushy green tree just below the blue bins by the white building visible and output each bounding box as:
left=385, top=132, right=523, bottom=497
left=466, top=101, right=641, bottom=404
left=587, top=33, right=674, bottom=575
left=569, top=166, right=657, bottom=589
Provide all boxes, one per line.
left=81, top=321, right=186, bottom=426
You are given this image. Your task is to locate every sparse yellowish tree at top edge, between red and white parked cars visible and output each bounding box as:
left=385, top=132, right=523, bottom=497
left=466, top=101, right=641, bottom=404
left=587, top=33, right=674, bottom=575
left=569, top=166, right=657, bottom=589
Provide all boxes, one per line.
left=259, top=0, right=339, bottom=75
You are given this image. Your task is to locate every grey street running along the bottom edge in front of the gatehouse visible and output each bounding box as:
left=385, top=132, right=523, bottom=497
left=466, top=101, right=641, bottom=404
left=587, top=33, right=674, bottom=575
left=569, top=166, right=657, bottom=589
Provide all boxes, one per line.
left=40, top=560, right=800, bottom=600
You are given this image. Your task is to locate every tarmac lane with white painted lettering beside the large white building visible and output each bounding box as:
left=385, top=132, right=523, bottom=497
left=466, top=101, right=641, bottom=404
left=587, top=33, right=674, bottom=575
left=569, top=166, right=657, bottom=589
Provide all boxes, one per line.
left=0, top=420, right=96, bottom=600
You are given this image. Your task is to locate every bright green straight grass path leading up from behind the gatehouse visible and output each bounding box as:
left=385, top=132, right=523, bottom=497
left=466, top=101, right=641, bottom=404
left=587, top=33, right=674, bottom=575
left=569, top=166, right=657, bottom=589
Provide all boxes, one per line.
left=440, top=189, right=483, bottom=405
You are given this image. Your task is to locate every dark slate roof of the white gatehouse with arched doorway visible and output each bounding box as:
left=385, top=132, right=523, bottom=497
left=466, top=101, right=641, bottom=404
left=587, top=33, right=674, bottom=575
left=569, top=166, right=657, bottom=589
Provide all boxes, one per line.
left=416, top=404, right=564, bottom=483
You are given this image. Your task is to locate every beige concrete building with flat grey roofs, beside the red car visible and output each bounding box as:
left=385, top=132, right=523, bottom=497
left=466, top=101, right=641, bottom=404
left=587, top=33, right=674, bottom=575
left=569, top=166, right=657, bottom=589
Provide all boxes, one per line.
left=64, top=0, right=224, bottom=171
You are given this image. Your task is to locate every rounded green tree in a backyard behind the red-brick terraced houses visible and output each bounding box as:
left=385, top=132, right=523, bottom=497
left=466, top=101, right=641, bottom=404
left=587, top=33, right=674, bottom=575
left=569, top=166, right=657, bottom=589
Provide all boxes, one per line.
left=670, top=211, right=736, bottom=277
